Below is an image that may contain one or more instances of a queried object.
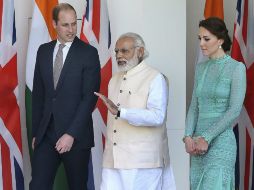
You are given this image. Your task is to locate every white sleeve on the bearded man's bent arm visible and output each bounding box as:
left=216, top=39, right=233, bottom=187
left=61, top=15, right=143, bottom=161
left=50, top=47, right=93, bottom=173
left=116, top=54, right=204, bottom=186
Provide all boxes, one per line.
left=120, top=74, right=168, bottom=126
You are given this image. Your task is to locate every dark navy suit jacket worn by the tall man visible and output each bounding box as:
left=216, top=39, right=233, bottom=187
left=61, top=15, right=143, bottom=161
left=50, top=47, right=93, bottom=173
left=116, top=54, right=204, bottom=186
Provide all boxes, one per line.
left=32, top=37, right=100, bottom=148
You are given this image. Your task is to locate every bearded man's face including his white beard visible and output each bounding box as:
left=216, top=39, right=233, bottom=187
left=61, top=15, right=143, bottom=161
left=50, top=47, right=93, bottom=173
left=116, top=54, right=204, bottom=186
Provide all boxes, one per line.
left=115, top=37, right=139, bottom=71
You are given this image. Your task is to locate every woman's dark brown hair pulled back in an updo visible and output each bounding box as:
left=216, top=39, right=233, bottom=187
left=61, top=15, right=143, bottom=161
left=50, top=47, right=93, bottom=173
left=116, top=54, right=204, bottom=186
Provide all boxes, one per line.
left=199, top=17, right=232, bottom=51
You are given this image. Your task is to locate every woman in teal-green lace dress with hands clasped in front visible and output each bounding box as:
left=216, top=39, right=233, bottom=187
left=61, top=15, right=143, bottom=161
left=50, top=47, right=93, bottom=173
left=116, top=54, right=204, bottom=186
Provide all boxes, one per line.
left=183, top=17, right=246, bottom=190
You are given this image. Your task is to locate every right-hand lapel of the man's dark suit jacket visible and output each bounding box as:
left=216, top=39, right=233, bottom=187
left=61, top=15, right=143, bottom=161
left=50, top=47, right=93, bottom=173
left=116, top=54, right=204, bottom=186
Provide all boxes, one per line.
left=56, top=37, right=79, bottom=91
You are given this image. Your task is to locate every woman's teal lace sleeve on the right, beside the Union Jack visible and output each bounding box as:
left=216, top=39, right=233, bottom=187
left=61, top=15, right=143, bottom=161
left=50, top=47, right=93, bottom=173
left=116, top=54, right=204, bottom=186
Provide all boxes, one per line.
left=201, top=64, right=246, bottom=144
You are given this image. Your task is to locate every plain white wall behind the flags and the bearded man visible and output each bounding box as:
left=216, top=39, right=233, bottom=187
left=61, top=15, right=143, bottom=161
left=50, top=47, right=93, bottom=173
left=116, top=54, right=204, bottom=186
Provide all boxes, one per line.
left=15, top=0, right=189, bottom=190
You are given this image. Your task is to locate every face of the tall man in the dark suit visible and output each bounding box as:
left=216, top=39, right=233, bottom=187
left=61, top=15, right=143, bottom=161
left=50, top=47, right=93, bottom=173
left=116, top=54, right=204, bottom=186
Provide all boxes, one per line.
left=53, top=10, right=77, bottom=44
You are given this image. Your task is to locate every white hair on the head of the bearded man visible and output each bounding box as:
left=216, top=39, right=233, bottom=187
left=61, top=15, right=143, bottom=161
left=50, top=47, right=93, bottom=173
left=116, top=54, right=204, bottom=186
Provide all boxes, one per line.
left=118, top=32, right=149, bottom=60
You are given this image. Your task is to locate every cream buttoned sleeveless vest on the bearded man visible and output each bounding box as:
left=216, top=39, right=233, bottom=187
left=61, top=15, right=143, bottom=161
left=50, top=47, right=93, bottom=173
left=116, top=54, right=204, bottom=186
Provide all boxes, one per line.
left=103, top=62, right=169, bottom=169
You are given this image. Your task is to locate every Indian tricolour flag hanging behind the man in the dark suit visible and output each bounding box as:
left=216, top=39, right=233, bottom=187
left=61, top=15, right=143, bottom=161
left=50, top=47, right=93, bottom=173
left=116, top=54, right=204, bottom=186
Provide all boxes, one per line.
left=26, top=0, right=68, bottom=190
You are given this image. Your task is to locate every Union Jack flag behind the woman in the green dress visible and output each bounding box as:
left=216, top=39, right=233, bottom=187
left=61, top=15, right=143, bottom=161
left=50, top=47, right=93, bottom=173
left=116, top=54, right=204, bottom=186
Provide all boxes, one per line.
left=231, top=0, right=254, bottom=190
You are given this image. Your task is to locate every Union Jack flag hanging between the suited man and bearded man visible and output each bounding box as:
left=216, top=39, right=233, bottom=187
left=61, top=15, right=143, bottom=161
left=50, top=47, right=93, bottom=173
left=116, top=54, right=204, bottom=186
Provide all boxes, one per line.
left=80, top=0, right=112, bottom=189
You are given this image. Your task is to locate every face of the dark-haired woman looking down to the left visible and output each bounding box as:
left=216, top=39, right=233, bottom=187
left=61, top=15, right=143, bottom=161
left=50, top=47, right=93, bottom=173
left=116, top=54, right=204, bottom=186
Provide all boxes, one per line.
left=198, top=27, right=222, bottom=58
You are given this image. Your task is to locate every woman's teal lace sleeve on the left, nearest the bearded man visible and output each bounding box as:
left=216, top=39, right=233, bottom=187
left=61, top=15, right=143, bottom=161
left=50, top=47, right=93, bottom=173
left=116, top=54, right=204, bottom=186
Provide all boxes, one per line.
left=185, top=65, right=198, bottom=136
